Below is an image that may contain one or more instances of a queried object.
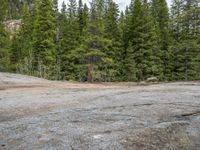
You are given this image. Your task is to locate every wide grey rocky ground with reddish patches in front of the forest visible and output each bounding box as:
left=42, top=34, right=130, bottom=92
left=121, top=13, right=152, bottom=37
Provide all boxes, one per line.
left=0, top=73, right=200, bottom=150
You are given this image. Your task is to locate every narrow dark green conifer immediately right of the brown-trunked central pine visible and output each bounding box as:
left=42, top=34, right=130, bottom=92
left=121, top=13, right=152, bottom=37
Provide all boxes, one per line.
left=104, top=0, right=122, bottom=81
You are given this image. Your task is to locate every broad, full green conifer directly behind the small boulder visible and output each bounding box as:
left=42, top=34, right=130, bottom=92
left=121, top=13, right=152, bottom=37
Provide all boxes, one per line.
left=130, top=0, right=162, bottom=80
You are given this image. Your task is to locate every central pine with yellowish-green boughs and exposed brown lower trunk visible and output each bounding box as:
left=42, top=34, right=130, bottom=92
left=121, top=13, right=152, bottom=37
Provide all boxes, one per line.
left=80, top=0, right=113, bottom=82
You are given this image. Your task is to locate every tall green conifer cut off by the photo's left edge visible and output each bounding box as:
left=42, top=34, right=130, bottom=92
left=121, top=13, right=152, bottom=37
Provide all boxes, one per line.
left=0, top=0, right=10, bottom=71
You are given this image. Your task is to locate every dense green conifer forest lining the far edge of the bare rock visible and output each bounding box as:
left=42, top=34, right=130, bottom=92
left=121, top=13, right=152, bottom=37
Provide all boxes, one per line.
left=0, top=0, right=200, bottom=82
